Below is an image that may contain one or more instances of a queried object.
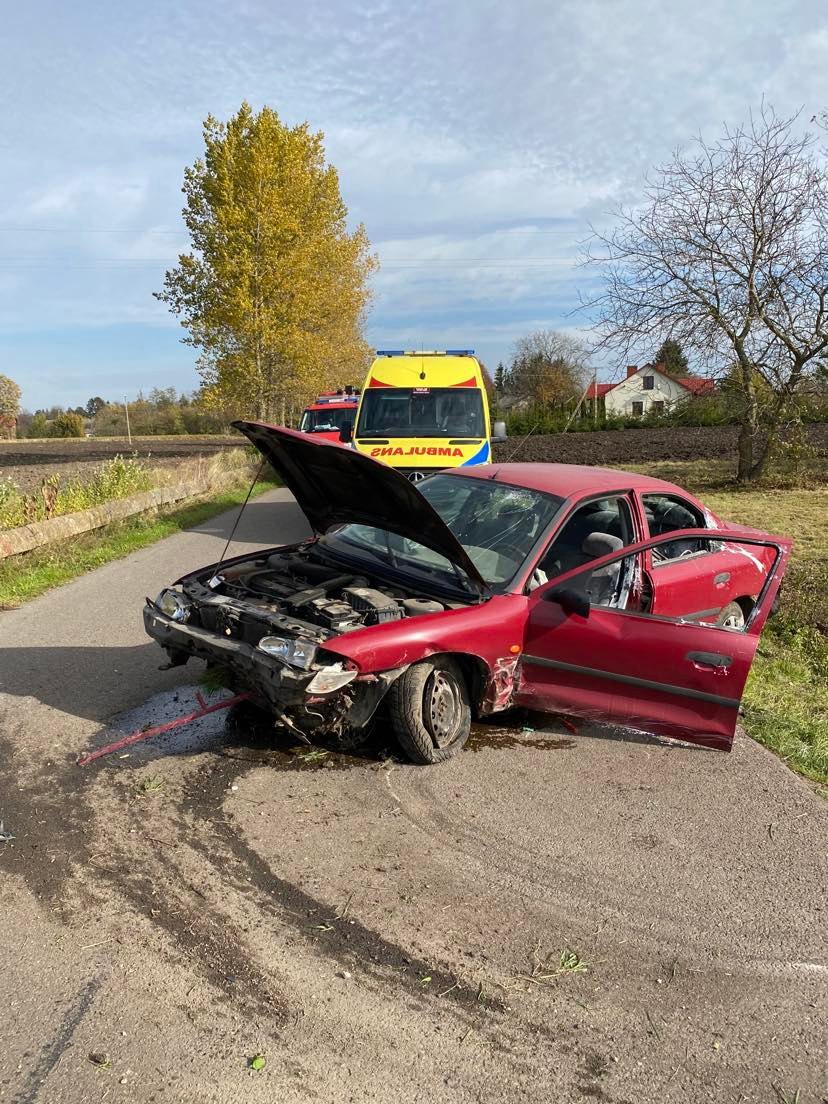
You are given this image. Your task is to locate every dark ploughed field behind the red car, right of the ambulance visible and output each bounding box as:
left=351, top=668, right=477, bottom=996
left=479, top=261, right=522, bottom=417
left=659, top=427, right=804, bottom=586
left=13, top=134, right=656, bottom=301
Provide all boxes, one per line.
left=493, top=415, right=828, bottom=465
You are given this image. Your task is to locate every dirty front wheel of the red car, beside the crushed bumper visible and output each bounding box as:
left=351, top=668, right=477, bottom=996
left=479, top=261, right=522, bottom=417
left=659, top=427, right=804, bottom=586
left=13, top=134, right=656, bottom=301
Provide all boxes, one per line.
left=388, top=657, right=471, bottom=765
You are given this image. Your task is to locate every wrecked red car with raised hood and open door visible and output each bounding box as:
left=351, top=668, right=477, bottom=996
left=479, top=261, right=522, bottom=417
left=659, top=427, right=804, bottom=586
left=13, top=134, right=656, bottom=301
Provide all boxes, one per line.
left=144, top=422, right=790, bottom=763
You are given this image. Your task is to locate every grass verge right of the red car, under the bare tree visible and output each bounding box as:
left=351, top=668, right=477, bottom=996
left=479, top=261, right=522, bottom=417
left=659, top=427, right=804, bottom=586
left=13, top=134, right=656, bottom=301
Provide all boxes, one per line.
left=636, top=461, right=828, bottom=796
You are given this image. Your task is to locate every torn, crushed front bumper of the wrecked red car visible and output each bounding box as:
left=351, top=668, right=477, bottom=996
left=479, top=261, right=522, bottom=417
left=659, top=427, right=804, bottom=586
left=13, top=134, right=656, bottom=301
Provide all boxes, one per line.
left=144, top=598, right=405, bottom=734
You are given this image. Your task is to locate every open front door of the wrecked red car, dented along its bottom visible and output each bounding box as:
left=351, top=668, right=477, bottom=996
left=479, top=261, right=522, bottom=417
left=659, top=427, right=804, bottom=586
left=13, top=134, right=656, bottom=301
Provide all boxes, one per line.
left=514, top=530, right=790, bottom=751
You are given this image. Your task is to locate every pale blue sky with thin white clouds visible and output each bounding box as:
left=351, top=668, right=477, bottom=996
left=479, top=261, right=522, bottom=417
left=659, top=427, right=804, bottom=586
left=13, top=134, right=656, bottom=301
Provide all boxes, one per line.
left=0, top=0, right=828, bottom=410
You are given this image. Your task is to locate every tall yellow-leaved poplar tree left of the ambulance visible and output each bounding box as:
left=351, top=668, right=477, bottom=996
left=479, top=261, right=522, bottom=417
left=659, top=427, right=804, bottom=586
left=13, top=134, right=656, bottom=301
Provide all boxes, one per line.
left=157, top=103, right=376, bottom=422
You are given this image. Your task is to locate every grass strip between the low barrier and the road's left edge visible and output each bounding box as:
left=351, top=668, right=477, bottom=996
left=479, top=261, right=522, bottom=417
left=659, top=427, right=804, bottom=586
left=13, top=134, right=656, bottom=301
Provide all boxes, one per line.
left=0, top=481, right=275, bottom=609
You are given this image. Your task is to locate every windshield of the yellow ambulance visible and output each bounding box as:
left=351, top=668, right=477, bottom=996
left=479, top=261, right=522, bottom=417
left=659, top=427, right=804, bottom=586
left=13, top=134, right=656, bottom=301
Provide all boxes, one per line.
left=357, top=388, right=486, bottom=437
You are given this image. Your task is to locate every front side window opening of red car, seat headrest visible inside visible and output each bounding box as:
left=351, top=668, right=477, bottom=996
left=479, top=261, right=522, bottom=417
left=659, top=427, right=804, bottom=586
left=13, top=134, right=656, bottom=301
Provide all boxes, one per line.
left=532, top=495, right=634, bottom=586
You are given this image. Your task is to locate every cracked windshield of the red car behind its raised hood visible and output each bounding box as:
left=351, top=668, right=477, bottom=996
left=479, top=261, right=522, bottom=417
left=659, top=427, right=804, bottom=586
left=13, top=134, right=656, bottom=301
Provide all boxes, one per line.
left=322, top=475, right=563, bottom=590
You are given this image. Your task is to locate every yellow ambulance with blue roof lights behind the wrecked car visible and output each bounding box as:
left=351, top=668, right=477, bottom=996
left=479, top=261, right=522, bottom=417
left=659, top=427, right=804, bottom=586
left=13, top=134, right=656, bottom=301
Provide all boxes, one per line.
left=352, top=349, right=500, bottom=482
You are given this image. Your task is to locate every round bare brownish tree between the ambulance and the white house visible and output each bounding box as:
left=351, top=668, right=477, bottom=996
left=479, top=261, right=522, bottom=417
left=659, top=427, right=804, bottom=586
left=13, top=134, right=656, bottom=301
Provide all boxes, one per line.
left=509, top=330, right=590, bottom=406
